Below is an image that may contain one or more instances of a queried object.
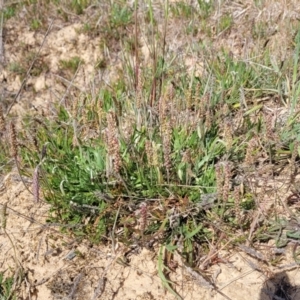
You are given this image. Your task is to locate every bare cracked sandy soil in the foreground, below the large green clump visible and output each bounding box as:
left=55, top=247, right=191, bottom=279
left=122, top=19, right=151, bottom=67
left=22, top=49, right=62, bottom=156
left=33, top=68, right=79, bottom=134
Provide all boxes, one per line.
left=0, top=173, right=300, bottom=300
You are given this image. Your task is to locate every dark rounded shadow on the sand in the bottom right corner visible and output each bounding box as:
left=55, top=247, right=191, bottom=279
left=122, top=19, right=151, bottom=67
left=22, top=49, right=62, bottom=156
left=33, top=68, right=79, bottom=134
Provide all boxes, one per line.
left=259, top=272, right=300, bottom=300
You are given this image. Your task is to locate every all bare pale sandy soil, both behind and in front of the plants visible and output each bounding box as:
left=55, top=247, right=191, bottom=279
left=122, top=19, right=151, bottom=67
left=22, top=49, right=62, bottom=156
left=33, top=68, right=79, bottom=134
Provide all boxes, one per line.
left=0, top=1, right=300, bottom=300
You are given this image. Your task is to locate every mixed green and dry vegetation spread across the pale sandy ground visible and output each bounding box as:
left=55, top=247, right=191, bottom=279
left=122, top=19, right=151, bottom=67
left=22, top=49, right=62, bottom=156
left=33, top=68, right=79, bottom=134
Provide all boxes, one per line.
left=0, top=0, right=300, bottom=298
